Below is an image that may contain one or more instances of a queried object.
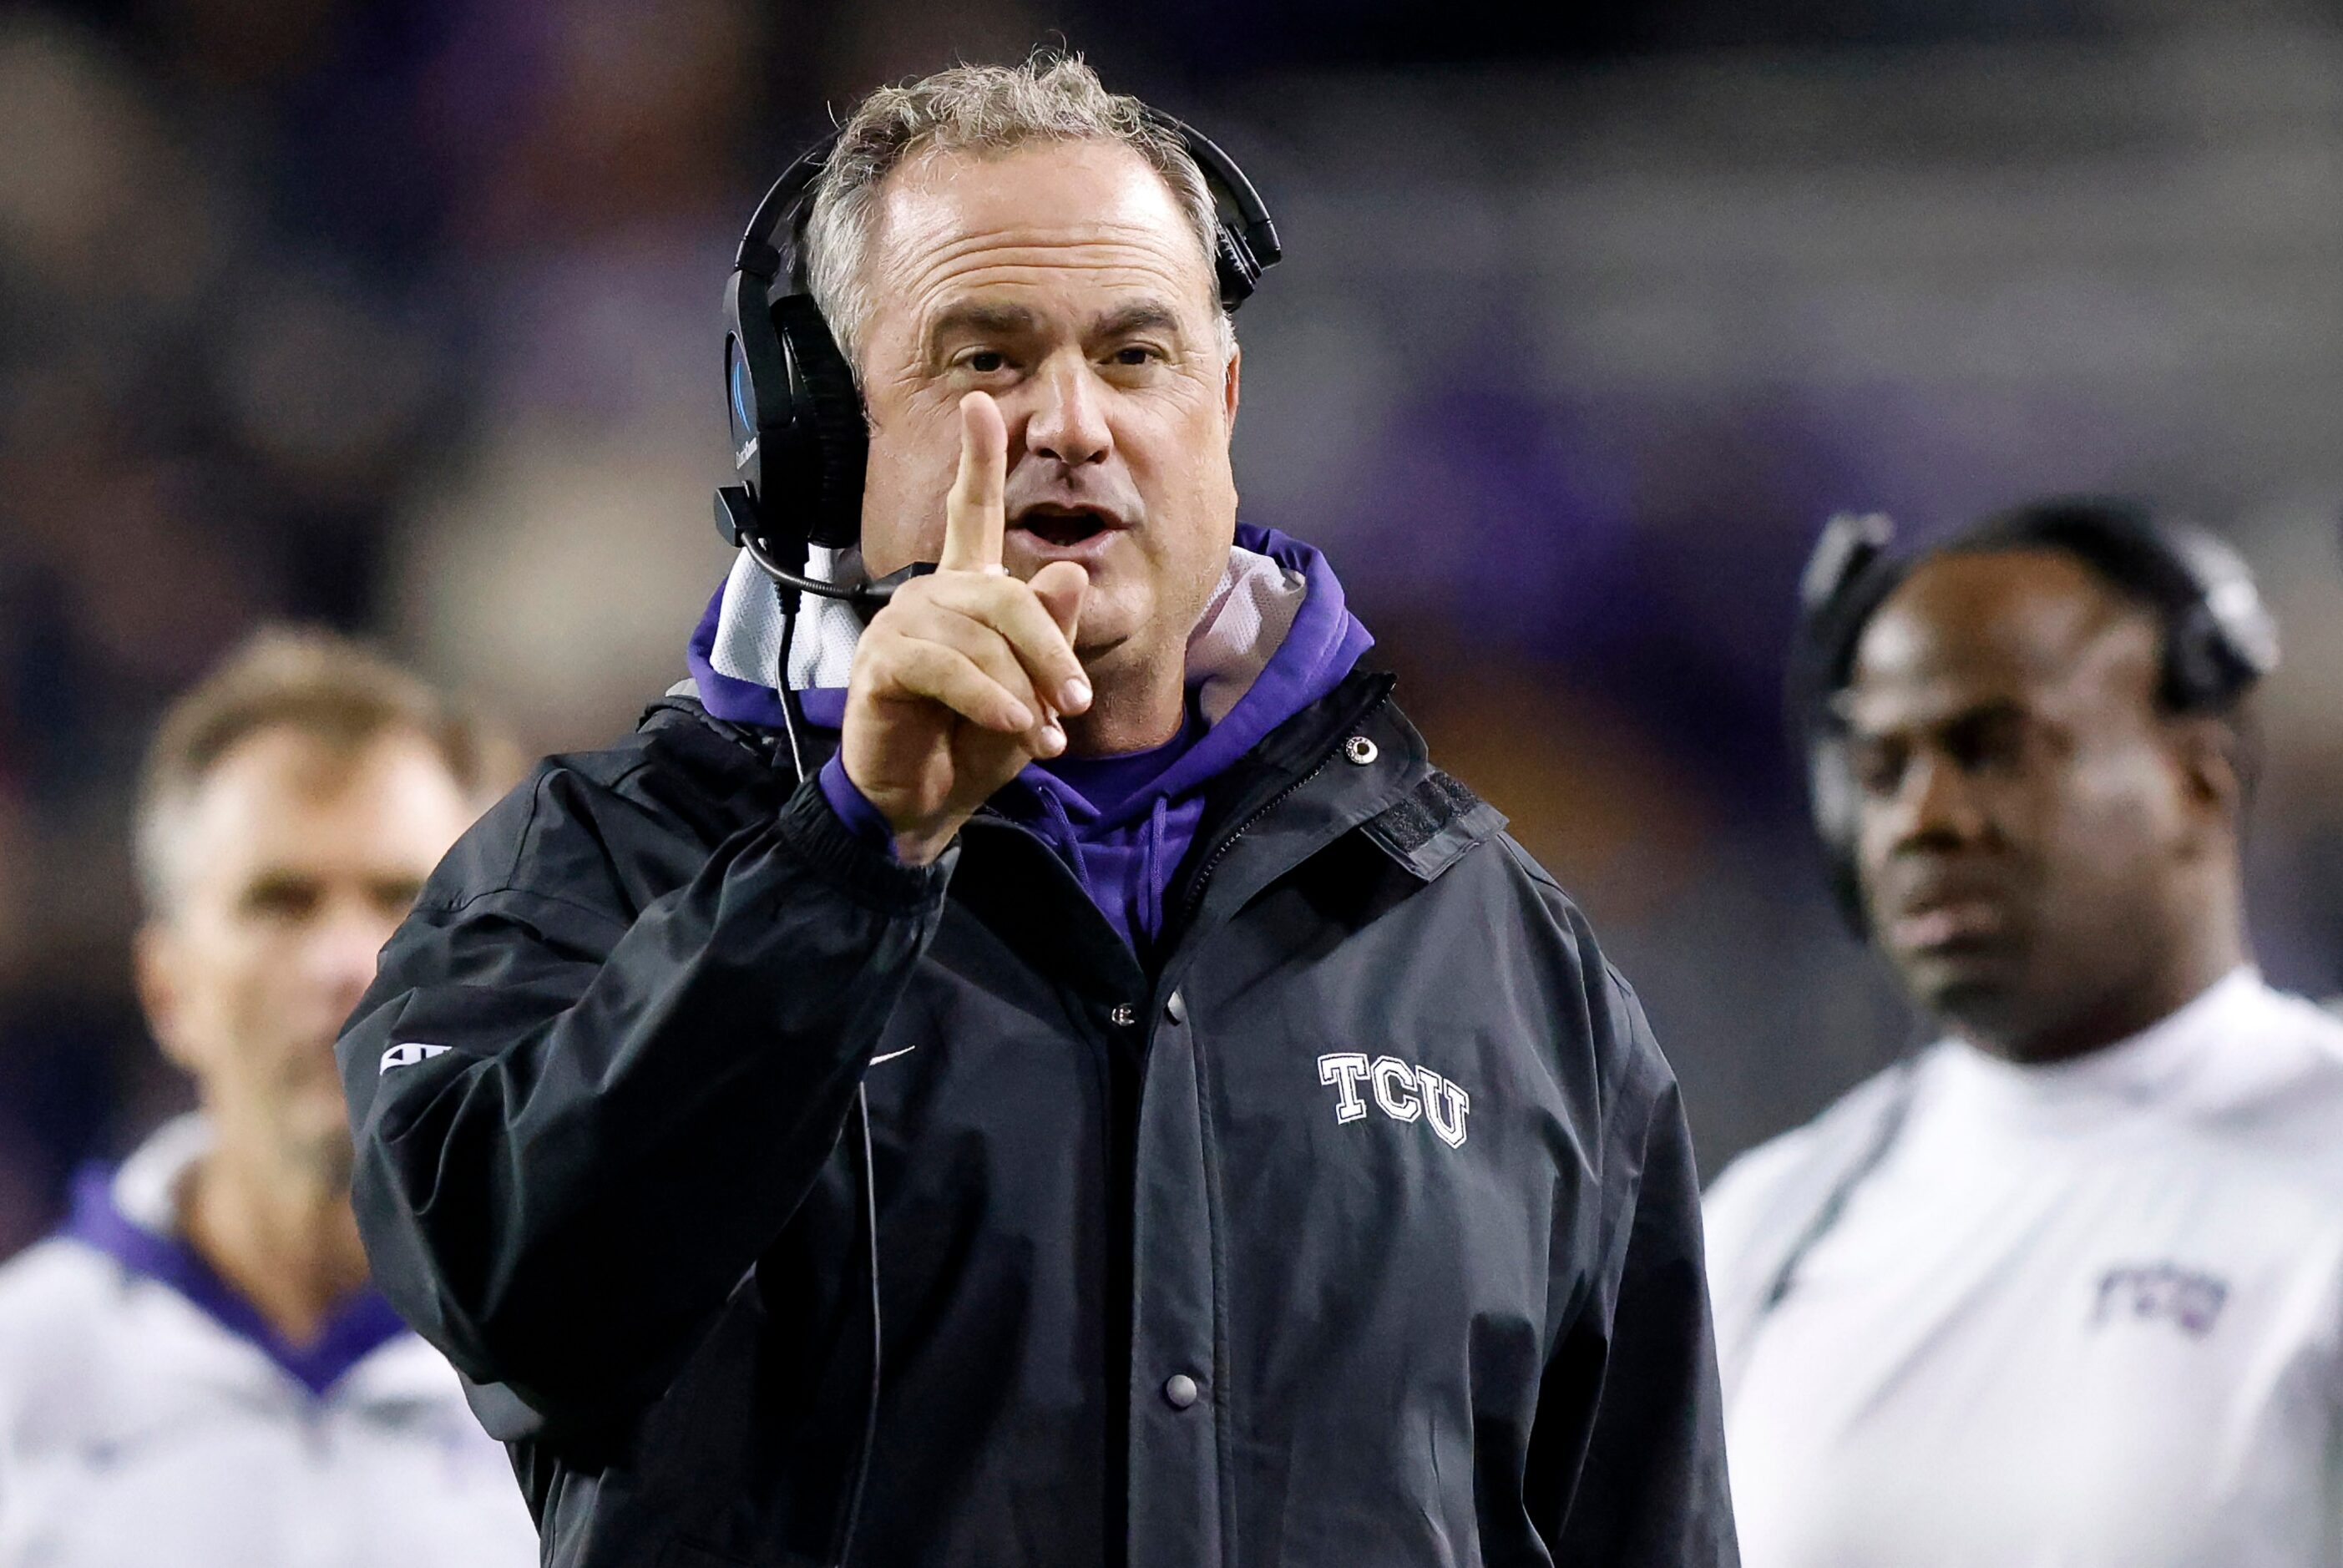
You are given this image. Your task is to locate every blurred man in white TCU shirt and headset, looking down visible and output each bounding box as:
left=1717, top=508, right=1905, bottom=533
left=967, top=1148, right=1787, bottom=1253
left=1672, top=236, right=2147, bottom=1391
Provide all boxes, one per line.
left=1708, top=502, right=2343, bottom=1568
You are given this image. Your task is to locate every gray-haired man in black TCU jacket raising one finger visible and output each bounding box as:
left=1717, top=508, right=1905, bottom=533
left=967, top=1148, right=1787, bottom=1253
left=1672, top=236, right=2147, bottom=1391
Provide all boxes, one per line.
left=342, top=58, right=1733, bottom=1568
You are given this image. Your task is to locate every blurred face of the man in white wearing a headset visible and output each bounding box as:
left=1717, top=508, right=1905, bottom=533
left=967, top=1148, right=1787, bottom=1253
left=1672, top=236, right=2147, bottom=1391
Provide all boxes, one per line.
left=1842, top=551, right=2233, bottom=1060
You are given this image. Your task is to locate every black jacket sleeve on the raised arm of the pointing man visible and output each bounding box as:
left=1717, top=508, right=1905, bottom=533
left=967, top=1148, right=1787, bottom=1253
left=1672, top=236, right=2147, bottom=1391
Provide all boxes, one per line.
left=337, top=766, right=954, bottom=1428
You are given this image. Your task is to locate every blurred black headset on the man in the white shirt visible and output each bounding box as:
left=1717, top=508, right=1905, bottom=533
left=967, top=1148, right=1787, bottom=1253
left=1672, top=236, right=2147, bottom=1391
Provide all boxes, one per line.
left=1783, top=497, right=2277, bottom=935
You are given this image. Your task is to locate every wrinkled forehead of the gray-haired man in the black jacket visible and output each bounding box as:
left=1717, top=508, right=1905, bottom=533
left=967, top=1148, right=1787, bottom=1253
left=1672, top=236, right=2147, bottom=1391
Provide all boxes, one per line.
left=872, top=140, right=1214, bottom=310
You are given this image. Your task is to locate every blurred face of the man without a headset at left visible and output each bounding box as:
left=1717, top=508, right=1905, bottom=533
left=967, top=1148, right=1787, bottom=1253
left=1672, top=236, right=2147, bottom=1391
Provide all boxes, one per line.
left=139, top=726, right=471, bottom=1174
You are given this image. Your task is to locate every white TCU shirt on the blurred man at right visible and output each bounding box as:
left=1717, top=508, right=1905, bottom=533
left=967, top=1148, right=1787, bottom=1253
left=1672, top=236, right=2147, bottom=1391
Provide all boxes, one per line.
left=1706, top=970, right=2343, bottom=1568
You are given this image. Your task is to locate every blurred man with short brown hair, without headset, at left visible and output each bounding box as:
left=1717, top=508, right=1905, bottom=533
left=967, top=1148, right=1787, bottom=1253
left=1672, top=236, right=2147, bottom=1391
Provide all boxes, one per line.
left=0, top=633, right=537, bottom=1568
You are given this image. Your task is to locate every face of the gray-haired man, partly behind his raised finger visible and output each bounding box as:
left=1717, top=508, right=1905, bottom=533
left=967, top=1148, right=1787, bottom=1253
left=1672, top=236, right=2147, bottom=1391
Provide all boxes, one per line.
left=860, top=140, right=1237, bottom=687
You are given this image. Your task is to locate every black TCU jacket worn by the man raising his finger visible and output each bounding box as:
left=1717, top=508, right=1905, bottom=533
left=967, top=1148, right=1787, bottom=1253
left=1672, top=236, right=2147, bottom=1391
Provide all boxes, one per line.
left=340, top=675, right=1733, bottom=1568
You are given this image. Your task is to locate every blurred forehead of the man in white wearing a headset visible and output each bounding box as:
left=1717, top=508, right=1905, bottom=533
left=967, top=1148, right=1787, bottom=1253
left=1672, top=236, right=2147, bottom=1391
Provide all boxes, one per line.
left=1839, top=551, right=2160, bottom=734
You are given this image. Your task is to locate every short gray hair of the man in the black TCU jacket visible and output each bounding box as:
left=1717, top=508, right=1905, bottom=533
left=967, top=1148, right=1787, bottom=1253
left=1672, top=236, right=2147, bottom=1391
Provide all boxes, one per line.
left=803, top=52, right=1237, bottom=380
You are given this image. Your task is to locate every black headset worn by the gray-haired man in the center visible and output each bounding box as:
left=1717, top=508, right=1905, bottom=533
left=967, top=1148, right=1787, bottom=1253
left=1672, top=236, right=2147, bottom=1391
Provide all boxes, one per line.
left=715, top=110, right=1284, bottom=604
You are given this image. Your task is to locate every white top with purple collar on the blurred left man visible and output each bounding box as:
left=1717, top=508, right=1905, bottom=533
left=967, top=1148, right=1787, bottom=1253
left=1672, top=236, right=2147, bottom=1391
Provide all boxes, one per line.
left=0, top=1118, right=537, bottom=1568
